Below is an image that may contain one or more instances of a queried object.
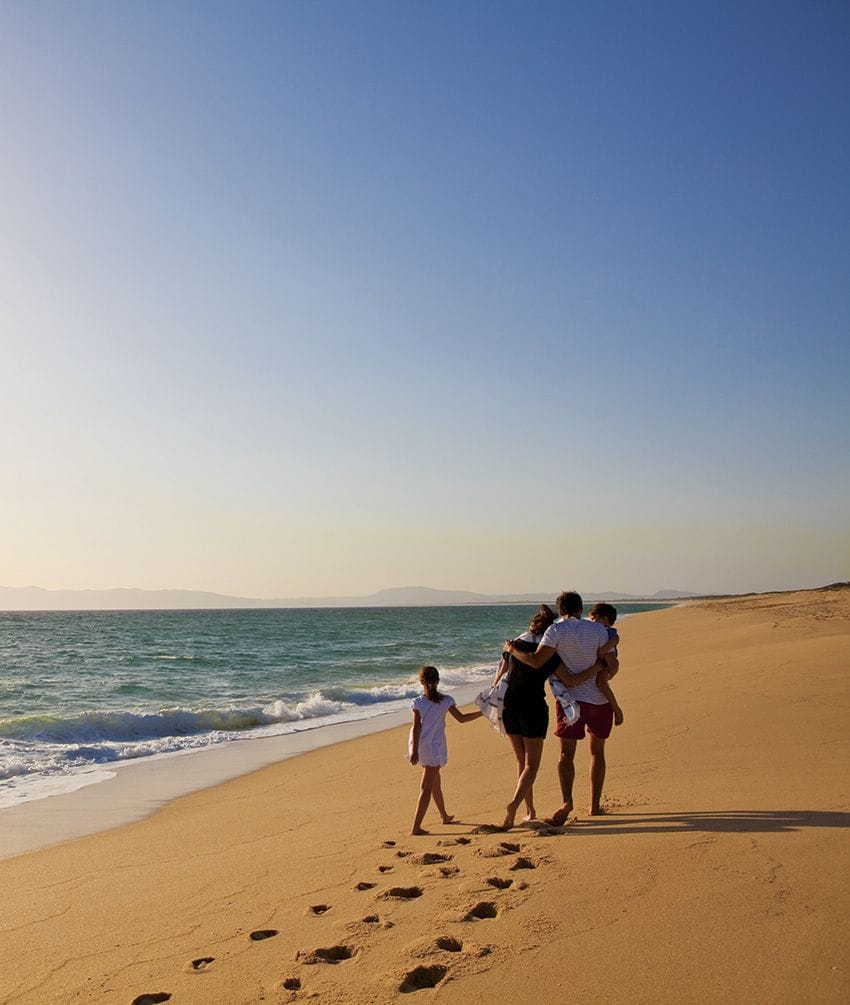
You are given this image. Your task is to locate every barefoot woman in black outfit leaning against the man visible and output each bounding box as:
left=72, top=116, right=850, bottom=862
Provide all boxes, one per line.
left=493, top=604, right=561, bottom=830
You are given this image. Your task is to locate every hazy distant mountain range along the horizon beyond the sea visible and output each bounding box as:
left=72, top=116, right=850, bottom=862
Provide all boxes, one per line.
left=0, top=586, right=701, bottom=611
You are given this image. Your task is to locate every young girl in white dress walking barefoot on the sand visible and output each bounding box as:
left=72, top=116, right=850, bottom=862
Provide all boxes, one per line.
left=410, top=666, right=481, bottom=834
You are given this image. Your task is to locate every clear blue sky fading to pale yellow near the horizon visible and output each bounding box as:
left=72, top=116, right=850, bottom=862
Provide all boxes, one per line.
left=0, top=0, right=850, bottom=597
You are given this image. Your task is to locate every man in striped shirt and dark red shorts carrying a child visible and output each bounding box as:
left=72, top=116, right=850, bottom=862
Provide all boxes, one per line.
left=505, top=591, right=615, bottom=826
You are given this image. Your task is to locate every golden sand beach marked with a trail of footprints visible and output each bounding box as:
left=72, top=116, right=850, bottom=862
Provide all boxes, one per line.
left=0, top=588, right=850, bottom=1005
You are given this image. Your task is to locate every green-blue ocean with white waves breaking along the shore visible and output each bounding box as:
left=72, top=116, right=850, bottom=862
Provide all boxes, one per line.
left=0, top=603, right=670, bottom=807
